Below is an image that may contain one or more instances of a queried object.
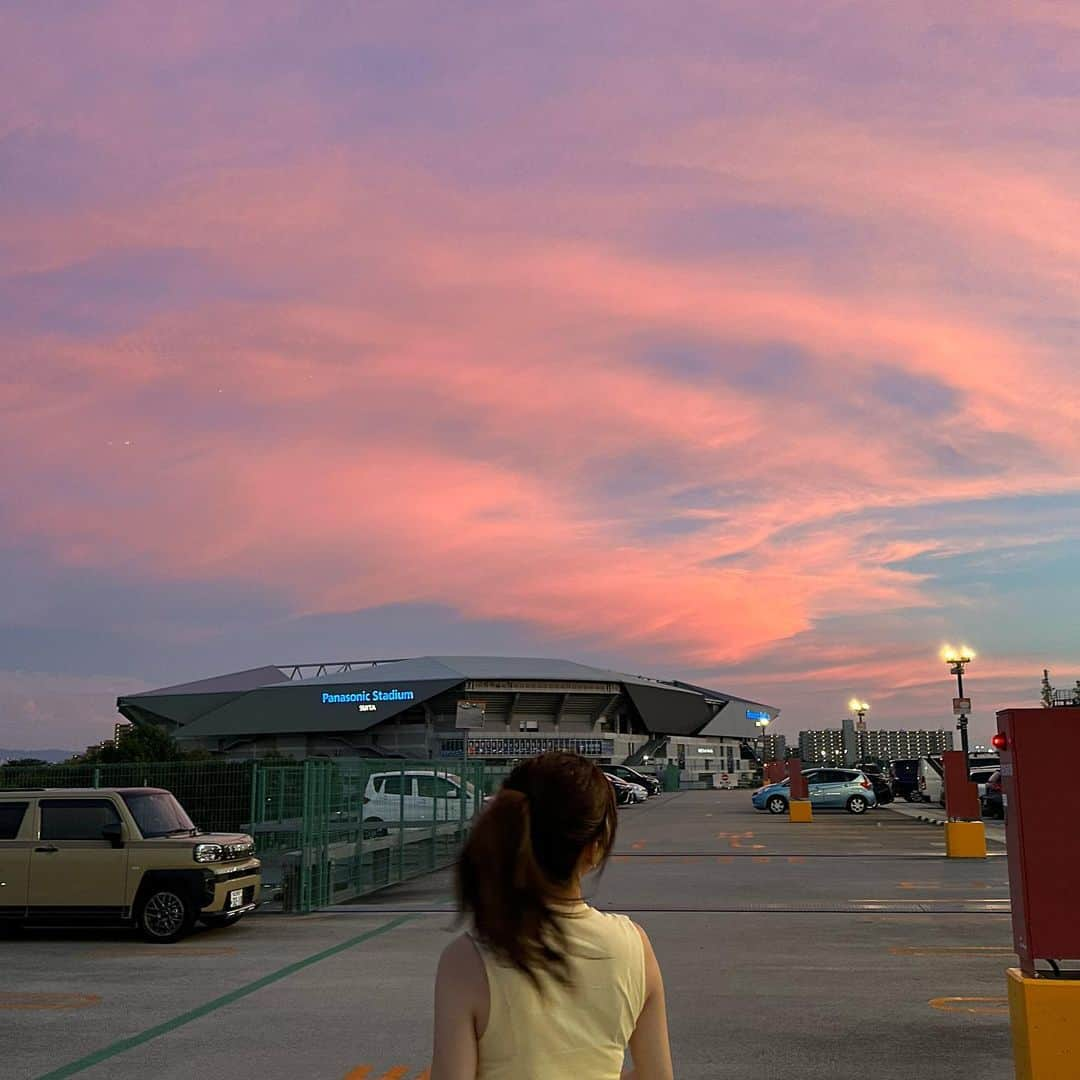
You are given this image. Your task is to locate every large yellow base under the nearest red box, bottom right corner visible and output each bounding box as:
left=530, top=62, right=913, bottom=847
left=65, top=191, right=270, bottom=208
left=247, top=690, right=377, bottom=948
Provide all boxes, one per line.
left=1009, top=968, right=1080, bottom=1080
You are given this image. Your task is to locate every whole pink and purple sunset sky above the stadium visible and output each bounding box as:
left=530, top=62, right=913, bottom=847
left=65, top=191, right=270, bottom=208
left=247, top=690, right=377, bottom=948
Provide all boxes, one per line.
left=0, top=0, right=1080, bottom=748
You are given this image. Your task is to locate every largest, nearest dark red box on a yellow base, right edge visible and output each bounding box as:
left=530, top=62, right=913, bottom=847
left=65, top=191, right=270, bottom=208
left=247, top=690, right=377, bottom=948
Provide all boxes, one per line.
left=995, top=707, right=1080, bottom=976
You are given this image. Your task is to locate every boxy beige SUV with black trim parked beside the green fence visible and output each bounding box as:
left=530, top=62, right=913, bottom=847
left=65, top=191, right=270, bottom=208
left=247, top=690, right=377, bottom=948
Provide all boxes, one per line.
left=0, top=787, right=260, bottom=942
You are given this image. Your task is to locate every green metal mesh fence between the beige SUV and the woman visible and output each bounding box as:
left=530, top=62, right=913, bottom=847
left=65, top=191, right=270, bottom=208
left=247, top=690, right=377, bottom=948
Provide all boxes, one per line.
left=0, top=758, right=490, bottom=912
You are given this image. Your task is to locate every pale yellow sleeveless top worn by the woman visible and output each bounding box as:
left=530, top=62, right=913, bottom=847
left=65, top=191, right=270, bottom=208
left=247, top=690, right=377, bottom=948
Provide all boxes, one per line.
left=476, top=903, right=645, bottom=1080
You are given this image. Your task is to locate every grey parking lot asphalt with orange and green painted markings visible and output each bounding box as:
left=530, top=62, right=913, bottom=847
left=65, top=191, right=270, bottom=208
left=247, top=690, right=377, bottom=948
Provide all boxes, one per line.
left=0, top=792, right=1015, bottom=1080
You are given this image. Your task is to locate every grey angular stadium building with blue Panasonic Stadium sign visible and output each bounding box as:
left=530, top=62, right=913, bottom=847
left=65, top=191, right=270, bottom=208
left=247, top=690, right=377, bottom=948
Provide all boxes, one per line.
left=117, top=657, right=780, bottom=784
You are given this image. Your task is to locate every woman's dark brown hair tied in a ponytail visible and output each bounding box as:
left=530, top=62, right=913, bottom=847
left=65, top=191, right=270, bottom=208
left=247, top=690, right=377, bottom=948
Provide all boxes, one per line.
left=457, top=753, right=617, bottom=986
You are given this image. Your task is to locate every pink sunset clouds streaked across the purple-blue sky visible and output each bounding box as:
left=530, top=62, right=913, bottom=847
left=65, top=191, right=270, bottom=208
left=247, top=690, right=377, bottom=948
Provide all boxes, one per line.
left=0, top=4, right=1080, bottom=738
